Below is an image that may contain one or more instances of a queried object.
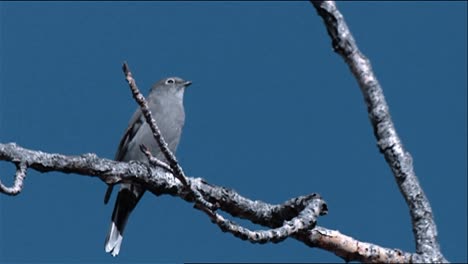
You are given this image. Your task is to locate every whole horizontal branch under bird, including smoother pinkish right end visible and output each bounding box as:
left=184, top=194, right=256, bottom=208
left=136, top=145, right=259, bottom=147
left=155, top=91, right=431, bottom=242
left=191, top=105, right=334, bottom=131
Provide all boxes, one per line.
left=0, top=143, right=417, bottom=262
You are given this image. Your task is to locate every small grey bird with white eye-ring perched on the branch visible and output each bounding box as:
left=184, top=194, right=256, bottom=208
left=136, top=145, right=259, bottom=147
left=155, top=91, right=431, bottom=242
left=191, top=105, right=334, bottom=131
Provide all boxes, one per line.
left=104, top=77, right=191, bottom=256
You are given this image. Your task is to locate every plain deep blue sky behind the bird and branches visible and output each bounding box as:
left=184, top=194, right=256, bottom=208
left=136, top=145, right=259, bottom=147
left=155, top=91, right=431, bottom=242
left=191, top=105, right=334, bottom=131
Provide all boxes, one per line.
left=0, top=1, right=467, bottom=263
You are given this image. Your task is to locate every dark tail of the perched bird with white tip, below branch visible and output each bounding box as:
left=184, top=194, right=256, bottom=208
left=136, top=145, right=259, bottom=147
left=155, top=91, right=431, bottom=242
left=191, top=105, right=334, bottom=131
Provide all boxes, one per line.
left=105, top=184, right=144, bottom=257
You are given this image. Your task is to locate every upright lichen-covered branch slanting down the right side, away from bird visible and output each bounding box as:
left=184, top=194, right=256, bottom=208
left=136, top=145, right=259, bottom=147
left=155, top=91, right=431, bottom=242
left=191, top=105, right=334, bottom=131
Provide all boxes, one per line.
left=311, top=1, right=447, bottom=262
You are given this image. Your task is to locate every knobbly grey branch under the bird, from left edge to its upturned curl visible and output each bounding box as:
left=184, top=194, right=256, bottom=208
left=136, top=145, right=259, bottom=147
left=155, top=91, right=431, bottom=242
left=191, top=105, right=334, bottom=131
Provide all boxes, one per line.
left=0, top=143, right=327, bottom=243
